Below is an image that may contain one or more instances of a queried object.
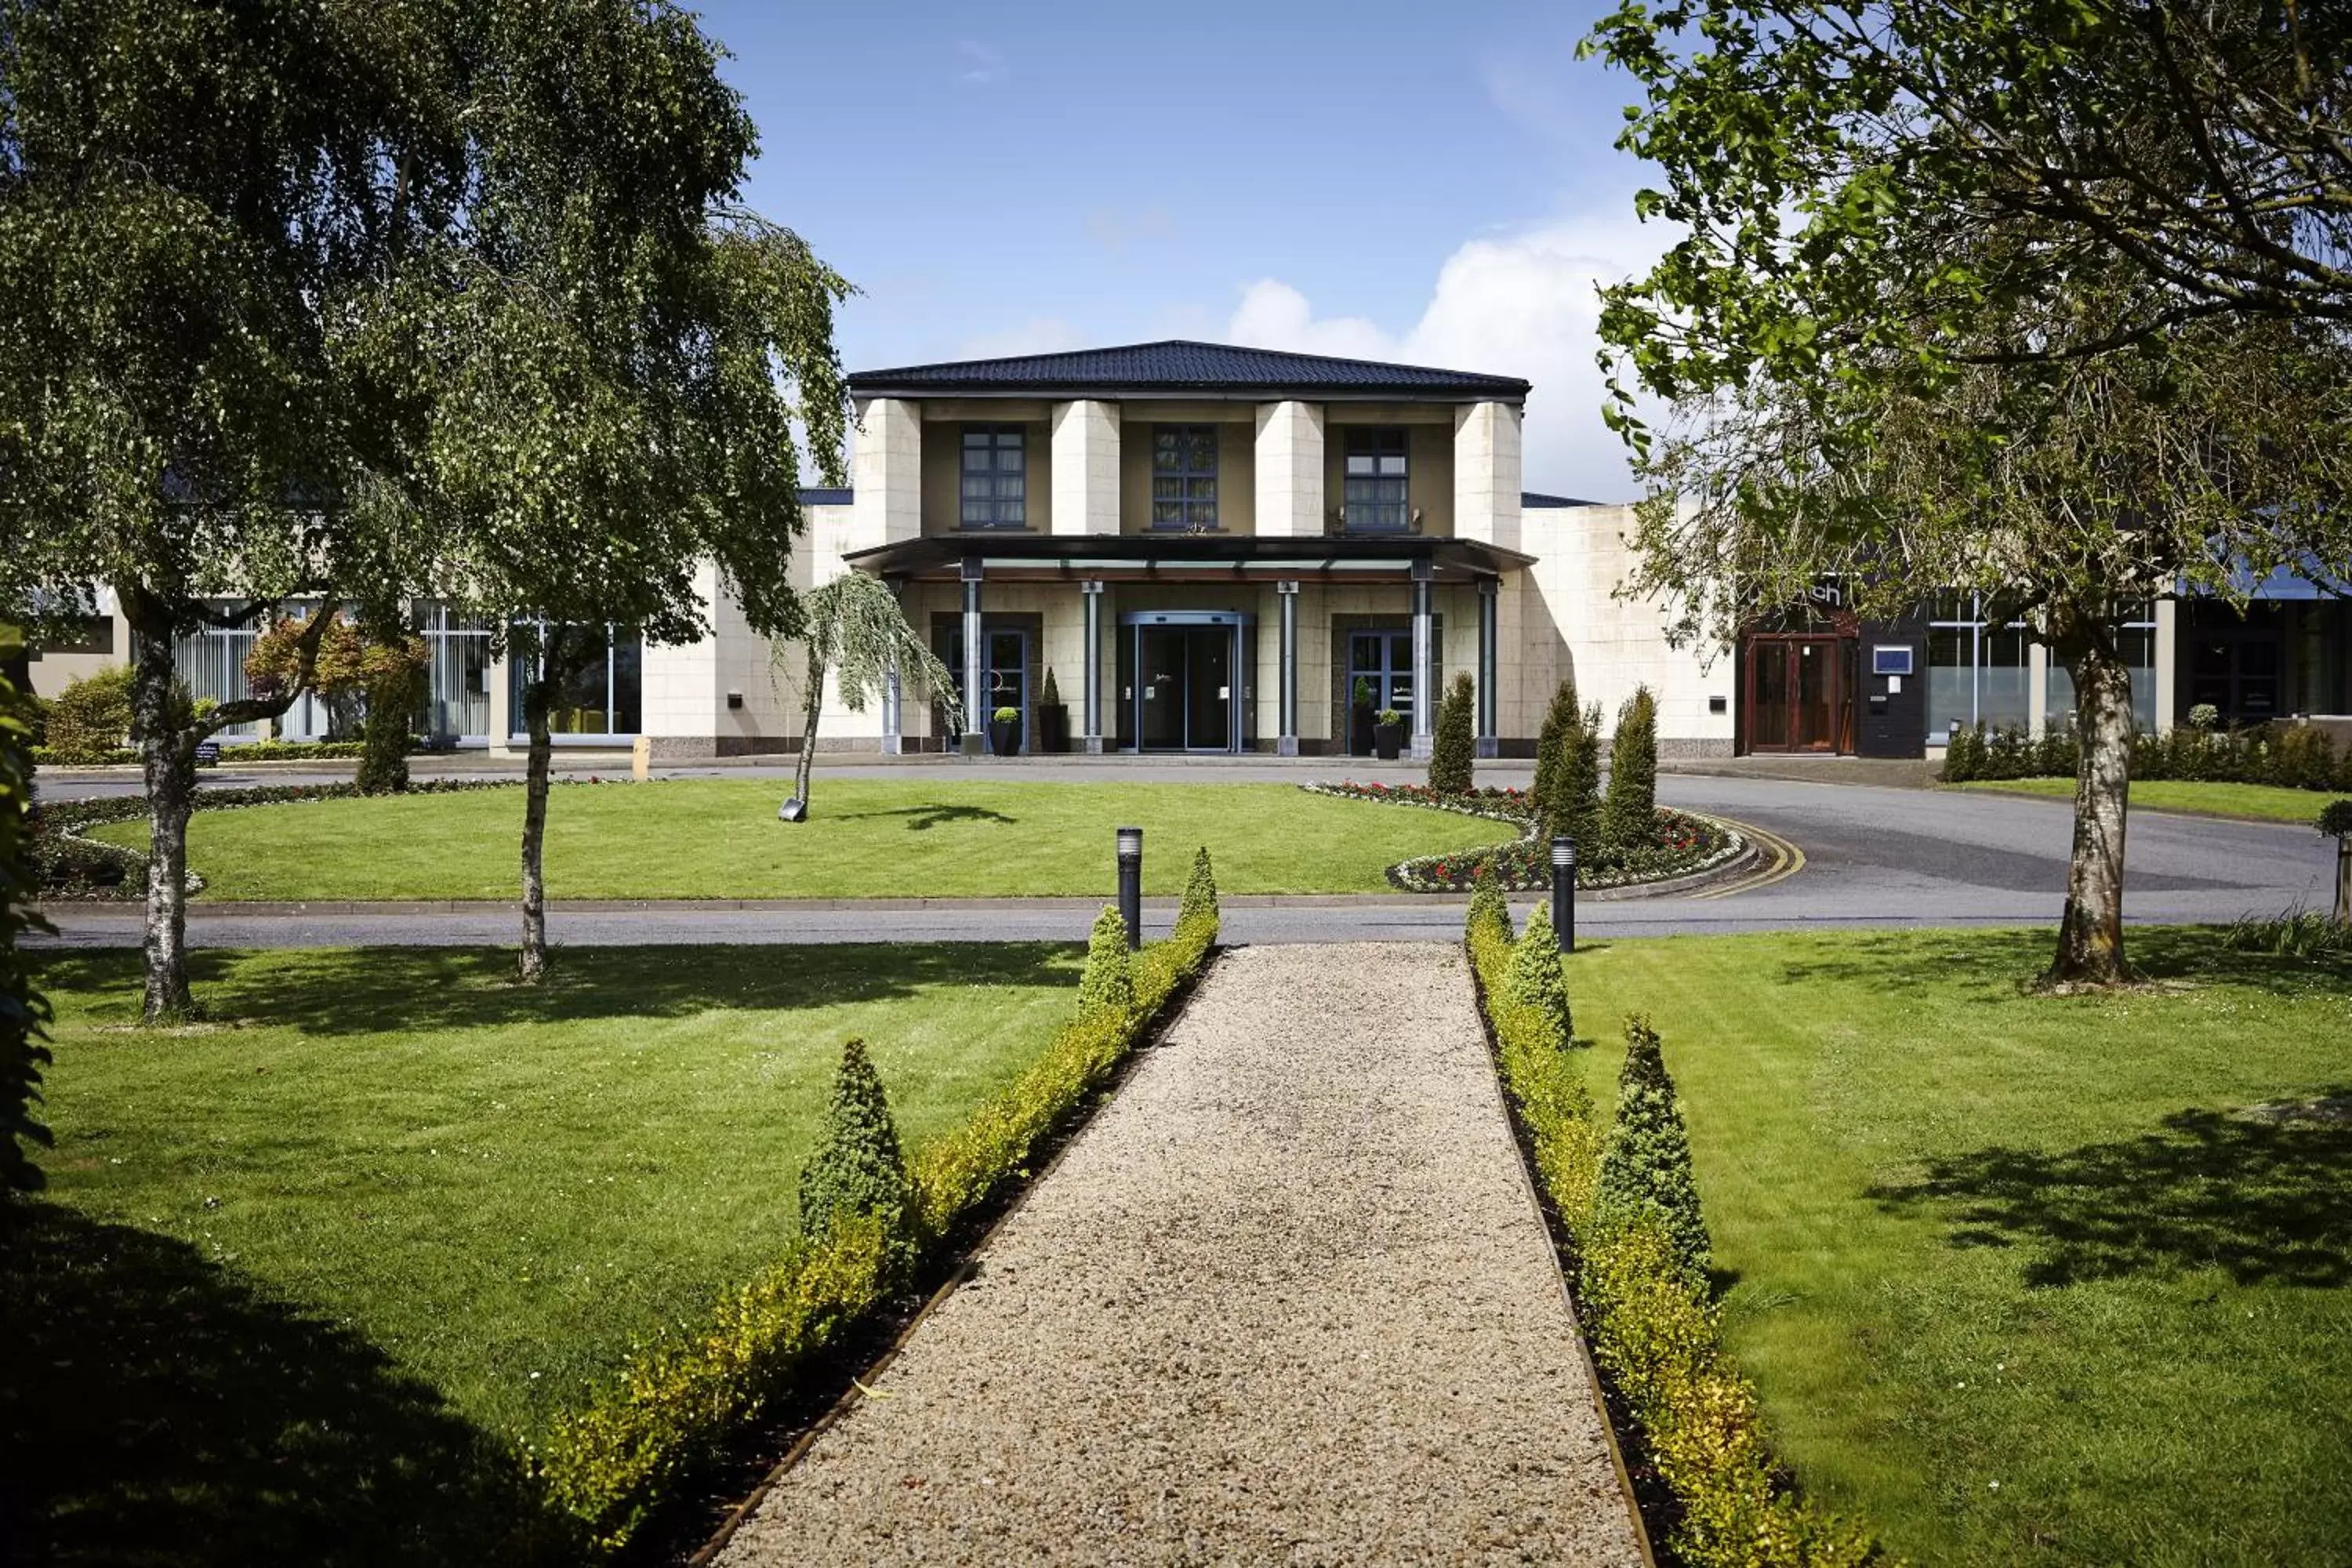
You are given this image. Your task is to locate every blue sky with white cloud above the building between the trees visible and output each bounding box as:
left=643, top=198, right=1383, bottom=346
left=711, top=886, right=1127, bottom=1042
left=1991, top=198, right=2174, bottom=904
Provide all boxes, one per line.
left=701, top=0, right=1661, bottom=499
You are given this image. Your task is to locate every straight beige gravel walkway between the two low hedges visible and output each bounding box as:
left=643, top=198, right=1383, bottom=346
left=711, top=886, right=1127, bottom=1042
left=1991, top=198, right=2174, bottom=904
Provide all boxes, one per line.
left=720, top=942, right=1642, bottom=1568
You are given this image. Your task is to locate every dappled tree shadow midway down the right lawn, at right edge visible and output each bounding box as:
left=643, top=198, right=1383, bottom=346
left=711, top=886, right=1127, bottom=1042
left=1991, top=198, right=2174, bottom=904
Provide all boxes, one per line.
left=1870, top=1088, right=2352, bottom=1288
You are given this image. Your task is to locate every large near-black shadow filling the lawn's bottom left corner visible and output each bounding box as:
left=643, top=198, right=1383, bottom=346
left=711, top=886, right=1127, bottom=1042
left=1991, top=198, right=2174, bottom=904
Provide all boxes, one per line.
left=0, top=1203, right=579, bottom=1568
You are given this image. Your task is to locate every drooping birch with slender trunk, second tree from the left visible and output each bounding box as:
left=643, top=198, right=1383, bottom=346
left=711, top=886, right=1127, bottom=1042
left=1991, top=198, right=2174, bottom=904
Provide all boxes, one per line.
left=369, top=0, right=849, bottom=980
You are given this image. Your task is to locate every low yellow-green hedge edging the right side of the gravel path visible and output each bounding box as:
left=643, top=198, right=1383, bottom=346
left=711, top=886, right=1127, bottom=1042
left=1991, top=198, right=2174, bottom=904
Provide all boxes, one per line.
left=1465, top=895, right=1877, bottom=1568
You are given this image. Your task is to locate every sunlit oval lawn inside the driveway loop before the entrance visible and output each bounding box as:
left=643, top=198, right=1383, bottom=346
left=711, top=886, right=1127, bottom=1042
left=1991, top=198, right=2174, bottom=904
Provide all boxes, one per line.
left=87, top=774, right=1515, bottom=900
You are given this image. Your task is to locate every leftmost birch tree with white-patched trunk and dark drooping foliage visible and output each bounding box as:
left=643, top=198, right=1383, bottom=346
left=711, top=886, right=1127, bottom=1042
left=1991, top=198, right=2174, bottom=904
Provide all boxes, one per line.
left=0, top=0, right=475, bottom=1018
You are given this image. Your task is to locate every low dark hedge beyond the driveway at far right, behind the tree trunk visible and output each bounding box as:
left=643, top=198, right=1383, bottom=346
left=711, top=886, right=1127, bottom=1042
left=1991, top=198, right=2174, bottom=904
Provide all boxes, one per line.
left=1938, top=724, right=2352, bottom=789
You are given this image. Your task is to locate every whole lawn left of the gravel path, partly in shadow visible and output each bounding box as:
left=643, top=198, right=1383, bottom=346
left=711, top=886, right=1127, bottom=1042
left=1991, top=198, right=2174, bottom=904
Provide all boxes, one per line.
left=0, top=945, right=1077, bottom=1563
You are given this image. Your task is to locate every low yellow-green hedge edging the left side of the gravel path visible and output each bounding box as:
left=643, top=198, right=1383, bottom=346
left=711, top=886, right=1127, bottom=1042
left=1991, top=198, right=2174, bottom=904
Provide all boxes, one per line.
left=527, top=865, right=1218, bottom=1552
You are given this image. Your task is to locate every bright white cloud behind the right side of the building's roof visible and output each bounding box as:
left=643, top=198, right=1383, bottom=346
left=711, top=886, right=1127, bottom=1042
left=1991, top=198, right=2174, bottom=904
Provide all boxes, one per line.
left=1225, top=216, right=1668, bottom=501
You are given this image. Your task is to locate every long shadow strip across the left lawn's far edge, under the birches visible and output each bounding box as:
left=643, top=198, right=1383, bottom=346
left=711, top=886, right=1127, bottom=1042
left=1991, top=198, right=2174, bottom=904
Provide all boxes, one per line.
left=40, top=940, right=1080, bottom=1034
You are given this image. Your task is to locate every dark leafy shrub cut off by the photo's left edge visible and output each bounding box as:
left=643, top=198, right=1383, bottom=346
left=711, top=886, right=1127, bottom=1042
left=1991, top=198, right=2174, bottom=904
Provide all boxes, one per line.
left=0, top=626, right=49, bottom=1201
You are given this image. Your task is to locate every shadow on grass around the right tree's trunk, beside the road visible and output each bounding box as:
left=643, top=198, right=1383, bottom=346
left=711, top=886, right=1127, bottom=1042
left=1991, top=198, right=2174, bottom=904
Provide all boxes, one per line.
left=1780, top=926, right=2352, bottom=1004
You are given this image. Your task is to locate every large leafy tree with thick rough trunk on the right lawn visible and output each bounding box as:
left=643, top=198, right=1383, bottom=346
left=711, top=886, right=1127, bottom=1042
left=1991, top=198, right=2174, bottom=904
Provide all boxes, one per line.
left=1592, top=0, right=2352, bottom=985
